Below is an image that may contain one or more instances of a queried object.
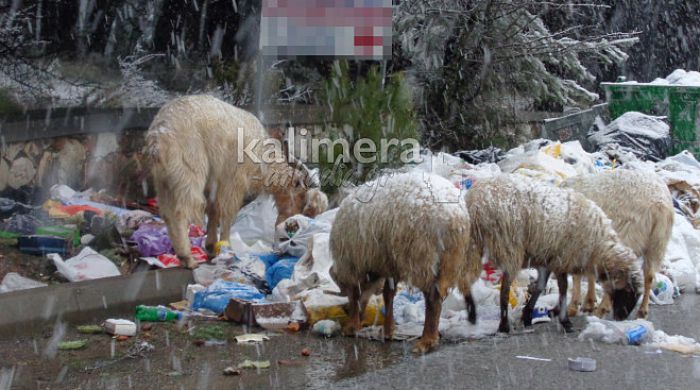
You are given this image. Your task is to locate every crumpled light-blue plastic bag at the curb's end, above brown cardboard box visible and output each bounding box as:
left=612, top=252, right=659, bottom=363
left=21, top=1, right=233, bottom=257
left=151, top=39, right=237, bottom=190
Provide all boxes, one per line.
left=192, top=279, right=265, bottom=314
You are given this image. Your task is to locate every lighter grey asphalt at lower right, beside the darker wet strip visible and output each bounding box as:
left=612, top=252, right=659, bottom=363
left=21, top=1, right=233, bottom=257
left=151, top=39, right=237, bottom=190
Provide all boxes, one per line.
left=334, top=292, right=700, bottom=390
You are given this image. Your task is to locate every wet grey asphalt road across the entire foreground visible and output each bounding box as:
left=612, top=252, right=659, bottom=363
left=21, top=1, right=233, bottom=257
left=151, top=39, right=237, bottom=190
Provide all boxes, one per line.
left=5, top=292, right=700, bottom=390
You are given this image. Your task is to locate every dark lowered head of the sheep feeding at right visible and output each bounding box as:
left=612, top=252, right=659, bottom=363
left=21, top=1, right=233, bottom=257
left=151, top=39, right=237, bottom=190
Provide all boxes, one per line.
left=599, top=250, right=642, bottom=321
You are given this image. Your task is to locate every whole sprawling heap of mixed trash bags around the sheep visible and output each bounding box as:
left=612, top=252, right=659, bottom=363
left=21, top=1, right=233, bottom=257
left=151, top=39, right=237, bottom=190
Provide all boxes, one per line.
left=0, top=109, right=700, bottom=350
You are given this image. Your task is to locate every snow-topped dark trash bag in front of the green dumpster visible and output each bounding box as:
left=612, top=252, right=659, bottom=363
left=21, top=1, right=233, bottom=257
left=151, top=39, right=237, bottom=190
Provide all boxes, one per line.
left=588, top=111, right=671, bottom=161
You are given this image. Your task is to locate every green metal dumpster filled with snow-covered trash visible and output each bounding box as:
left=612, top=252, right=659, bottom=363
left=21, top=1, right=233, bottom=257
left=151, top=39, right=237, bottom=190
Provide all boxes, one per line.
left=601, top=83, right=700, bottom=158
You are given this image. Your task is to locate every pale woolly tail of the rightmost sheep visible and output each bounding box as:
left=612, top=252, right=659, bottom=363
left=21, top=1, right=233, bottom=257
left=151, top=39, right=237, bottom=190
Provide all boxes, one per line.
left=644, top=203, right=674, bottom=274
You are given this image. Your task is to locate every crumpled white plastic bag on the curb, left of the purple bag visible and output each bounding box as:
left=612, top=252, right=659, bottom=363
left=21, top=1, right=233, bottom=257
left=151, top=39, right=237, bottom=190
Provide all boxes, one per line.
left=46, top=247, right=121, bottom=282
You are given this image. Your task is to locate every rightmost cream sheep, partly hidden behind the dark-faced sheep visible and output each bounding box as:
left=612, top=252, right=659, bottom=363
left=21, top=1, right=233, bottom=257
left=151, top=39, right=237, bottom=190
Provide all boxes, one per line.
left=562, top=169, right=674, bottom=319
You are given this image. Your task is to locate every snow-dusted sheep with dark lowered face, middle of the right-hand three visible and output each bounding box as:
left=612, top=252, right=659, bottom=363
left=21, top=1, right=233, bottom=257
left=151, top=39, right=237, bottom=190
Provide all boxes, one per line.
left=466, top=175, right=641, bottom=332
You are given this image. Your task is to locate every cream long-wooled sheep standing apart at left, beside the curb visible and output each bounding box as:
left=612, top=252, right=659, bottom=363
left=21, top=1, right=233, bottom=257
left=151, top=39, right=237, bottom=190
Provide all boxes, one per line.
left=145, top=95, right=318, bottom=268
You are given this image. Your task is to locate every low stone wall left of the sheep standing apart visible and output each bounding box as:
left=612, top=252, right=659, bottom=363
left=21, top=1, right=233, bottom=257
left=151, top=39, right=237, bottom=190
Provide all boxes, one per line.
left=0, top=130, right=152, bottom=202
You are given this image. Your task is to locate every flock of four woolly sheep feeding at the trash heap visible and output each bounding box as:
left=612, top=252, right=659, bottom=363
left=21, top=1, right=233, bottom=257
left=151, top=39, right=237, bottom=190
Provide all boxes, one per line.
left=147, top=96, right=674, bottom=353
